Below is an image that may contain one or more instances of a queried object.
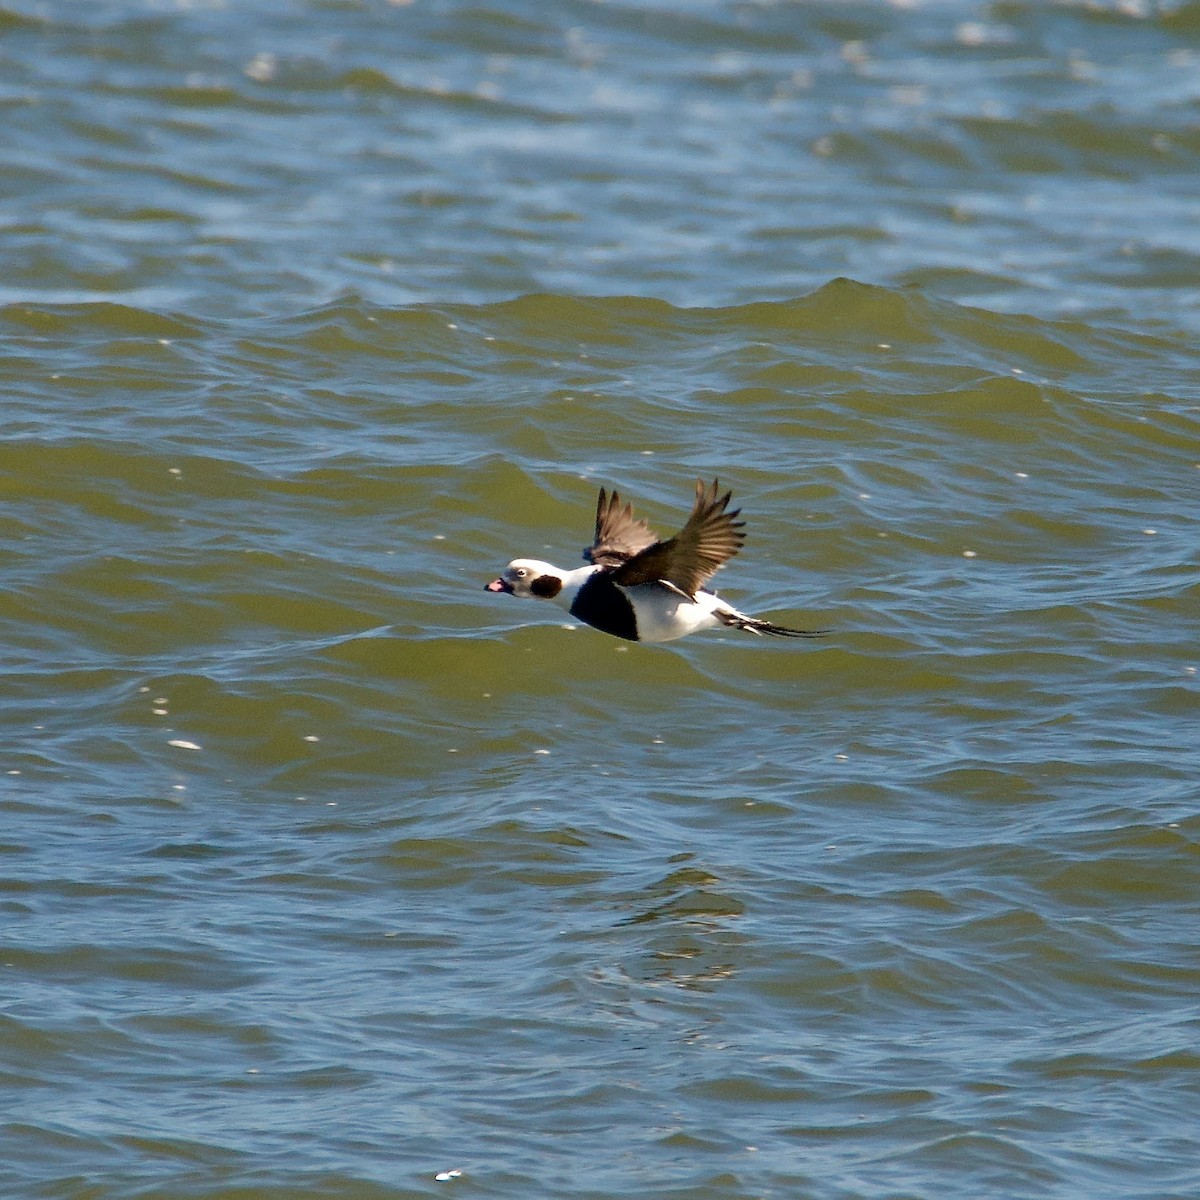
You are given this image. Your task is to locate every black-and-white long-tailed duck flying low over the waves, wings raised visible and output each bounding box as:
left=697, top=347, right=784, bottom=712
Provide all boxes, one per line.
left=486, top=479, right=827, bottom=642
